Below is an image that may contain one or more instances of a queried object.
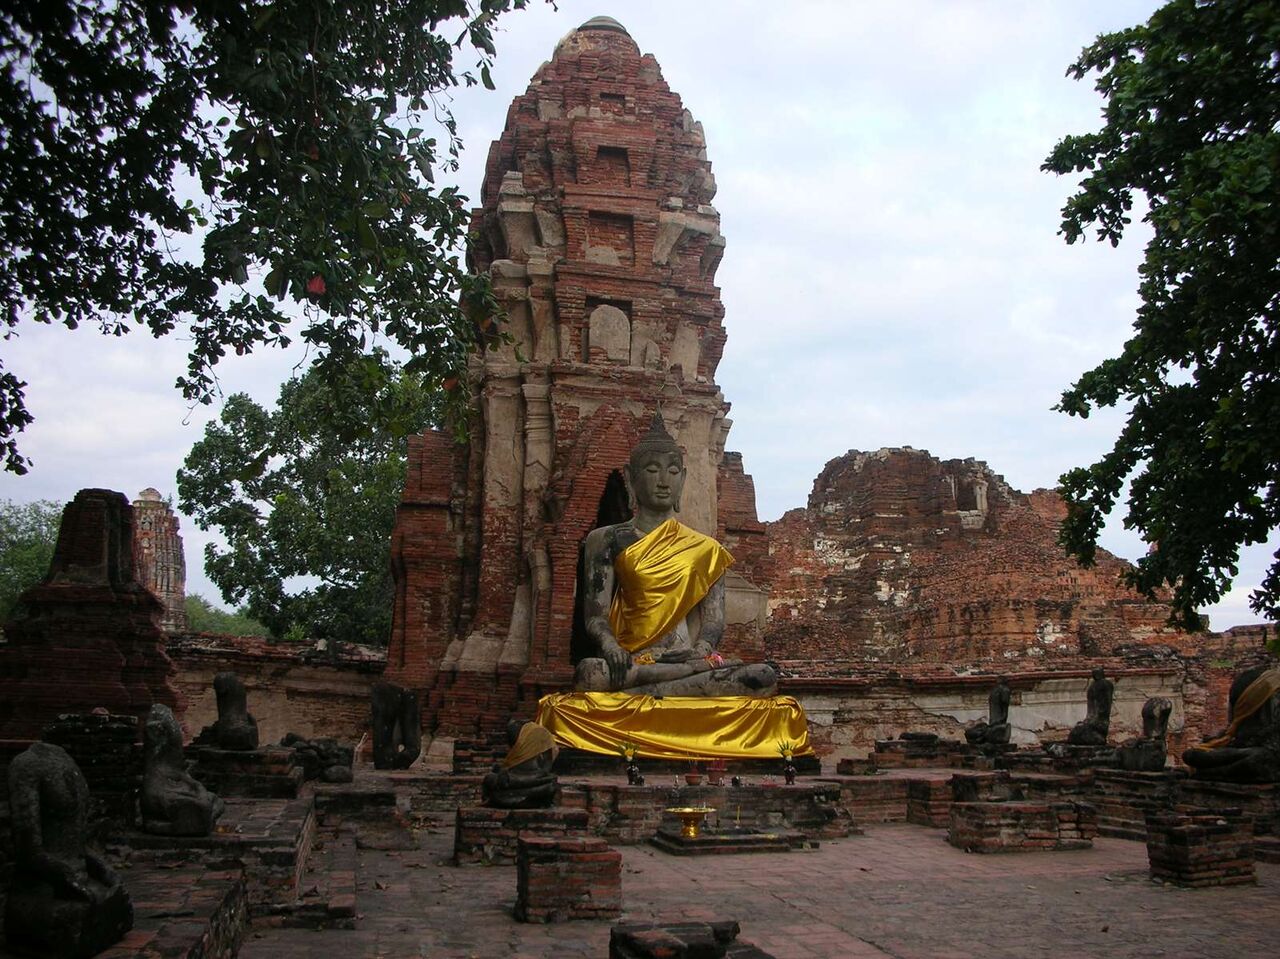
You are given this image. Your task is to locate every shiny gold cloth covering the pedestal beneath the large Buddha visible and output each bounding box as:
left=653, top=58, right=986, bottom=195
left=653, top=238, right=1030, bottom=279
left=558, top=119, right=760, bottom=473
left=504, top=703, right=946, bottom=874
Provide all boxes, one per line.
left=538, top=693, right=813, bottom=759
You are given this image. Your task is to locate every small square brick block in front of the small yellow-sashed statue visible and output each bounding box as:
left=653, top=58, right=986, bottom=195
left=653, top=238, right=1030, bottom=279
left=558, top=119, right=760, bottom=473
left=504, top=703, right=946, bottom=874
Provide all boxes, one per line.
left=516, top=836, right=622, bottom=922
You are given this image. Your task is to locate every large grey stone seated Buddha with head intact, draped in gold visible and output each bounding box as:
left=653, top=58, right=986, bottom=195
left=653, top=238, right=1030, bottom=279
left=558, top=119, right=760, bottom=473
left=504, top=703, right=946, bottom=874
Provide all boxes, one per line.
left=575, top=414, right=777, bottom=697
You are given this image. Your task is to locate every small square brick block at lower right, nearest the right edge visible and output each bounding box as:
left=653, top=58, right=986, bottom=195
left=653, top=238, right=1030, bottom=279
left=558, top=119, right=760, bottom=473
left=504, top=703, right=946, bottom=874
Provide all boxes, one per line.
left=1147, top=809, right=1257, bottom=887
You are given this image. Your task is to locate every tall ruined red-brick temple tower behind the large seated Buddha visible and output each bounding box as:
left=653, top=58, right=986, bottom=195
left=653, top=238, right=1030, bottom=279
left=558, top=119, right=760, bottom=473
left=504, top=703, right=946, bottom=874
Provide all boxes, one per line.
left=387, top=17, right=764, bottom=735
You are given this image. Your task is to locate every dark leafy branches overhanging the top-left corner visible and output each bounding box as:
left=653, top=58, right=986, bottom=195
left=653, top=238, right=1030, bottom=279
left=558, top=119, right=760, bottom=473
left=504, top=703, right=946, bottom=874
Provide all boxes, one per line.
left=0, top=0, right=525, bottom=474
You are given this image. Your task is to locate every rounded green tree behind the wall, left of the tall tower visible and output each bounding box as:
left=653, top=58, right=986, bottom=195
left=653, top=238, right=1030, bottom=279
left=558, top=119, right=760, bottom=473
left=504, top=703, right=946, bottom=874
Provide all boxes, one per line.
left=178, top=351, right=442, bottom=644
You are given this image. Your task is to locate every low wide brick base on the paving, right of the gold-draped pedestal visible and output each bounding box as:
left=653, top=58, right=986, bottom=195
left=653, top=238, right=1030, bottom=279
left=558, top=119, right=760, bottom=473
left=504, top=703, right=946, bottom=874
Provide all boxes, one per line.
left=947, top=802, right=1098, bottom=853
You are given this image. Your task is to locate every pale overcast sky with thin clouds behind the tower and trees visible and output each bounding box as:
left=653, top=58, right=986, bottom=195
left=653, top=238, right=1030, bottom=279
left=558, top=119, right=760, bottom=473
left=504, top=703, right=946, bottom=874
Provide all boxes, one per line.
left=0, top=0, right=1274, bottom=629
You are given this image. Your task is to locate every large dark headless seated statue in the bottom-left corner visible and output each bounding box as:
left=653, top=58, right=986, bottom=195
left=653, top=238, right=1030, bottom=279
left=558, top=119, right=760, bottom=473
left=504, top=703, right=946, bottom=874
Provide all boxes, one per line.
left=4, top=743, right=133, bottom=959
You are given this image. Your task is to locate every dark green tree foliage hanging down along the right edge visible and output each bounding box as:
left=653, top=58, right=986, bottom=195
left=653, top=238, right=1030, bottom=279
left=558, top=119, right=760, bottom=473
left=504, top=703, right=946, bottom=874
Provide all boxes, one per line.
left=1044, top=0, right=1280, bottom=629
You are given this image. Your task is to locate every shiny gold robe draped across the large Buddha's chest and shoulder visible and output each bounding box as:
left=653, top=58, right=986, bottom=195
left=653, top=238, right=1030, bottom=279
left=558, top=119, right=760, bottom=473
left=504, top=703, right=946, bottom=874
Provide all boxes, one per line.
left=609, top=519, right=733, bottom=653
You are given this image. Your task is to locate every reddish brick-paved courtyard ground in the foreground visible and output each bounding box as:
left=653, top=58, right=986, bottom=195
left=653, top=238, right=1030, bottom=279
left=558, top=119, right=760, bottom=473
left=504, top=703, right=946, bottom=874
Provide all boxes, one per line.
left=241, top=825, right=1280, bottom=959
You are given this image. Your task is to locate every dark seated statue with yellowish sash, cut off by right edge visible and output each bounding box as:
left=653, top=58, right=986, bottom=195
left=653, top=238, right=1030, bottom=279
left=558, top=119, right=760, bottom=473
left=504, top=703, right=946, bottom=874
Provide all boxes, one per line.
left=1183, top=667, right=1280, bottom=784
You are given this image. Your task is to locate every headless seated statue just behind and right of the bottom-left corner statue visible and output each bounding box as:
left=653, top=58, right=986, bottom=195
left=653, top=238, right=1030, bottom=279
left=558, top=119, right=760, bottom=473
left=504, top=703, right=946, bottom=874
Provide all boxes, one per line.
left=141, top=703, right=227, bottom=836
